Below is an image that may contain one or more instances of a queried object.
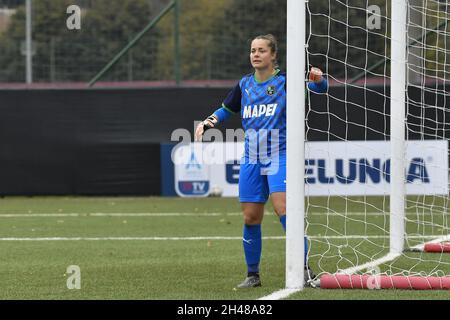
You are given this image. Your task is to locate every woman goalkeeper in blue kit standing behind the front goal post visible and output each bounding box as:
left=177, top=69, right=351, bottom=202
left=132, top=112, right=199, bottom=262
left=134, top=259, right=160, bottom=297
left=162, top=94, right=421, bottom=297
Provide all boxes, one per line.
left=195, top=34, right=328, bottom=288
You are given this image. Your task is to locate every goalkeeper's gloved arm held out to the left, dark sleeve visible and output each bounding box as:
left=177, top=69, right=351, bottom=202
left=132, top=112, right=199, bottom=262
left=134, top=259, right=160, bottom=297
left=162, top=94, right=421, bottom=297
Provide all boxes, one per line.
left=194, top=84, right=241, bottom=141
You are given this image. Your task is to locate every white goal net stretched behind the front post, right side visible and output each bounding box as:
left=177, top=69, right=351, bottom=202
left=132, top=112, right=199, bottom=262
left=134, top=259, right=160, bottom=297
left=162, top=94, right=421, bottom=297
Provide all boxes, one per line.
left=294, top=0, right=450, bottom=289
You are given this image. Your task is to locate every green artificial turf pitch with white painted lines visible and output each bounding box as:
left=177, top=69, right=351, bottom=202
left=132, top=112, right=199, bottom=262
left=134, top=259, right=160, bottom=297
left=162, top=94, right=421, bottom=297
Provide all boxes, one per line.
left=0, top=197, right=450, bottom=300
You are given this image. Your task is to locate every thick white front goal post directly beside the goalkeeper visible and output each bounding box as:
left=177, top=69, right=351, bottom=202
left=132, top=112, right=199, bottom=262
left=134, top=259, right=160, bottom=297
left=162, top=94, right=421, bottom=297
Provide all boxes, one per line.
left=286, top=0, right=306, bottom=289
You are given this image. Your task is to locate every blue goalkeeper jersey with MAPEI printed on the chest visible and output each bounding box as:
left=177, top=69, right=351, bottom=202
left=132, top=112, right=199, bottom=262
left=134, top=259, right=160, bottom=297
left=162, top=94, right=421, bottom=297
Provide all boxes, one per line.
left=222, top=70, right=327, bottom=159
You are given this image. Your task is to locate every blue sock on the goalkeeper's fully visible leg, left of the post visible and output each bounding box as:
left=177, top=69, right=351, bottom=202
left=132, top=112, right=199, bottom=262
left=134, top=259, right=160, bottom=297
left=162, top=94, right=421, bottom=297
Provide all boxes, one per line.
left=242, top=224, right=262, bottom=273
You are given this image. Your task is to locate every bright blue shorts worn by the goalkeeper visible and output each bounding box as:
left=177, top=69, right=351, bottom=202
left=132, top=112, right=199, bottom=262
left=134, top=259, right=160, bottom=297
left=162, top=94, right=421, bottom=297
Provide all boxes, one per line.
left=239, top=156, right=286, bottom=203
